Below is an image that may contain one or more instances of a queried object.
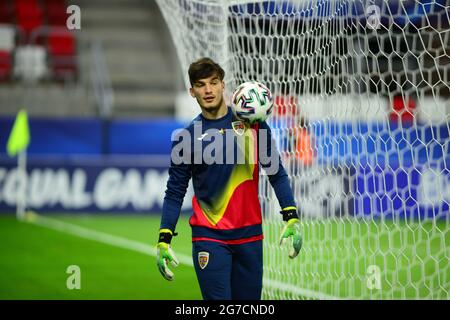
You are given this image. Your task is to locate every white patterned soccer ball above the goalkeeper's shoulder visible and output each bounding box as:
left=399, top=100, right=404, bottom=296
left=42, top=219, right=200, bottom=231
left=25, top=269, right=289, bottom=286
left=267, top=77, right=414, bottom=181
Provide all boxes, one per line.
left=231, top=81, right=273, bottom=124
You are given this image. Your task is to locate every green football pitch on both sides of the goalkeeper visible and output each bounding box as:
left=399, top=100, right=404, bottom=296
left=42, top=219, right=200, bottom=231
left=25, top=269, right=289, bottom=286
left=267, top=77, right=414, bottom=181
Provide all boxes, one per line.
left=0, top=214, right=449, bottom=300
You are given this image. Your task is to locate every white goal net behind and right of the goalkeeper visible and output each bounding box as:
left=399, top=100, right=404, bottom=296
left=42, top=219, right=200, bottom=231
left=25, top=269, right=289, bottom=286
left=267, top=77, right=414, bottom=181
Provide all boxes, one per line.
left=158, top=0, right=450, bottom=299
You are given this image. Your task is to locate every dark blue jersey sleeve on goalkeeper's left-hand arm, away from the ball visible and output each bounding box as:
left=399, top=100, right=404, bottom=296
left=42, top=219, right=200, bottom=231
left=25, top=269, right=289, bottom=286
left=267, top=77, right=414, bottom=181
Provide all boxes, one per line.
left=160, top=134, right=192, bottom=232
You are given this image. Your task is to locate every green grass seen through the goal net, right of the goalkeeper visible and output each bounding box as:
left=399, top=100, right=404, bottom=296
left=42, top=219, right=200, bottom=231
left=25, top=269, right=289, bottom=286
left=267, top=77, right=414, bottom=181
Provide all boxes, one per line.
left=264, top=218, right=450, bottom=299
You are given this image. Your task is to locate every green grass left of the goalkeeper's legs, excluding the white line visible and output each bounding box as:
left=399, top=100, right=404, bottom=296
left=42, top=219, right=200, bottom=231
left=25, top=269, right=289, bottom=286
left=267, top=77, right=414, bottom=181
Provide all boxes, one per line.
left=0, top=215, right=201, bottom=300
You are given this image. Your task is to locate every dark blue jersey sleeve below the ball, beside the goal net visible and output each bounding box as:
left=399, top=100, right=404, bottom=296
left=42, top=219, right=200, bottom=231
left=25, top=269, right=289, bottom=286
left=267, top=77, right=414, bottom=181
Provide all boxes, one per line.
left=259, top=121, right=296, bottom=209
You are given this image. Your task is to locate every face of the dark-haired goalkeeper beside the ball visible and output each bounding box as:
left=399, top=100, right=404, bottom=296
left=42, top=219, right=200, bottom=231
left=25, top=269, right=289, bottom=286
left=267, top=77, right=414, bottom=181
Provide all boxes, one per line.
left=189, top=75, right=225, bottom=111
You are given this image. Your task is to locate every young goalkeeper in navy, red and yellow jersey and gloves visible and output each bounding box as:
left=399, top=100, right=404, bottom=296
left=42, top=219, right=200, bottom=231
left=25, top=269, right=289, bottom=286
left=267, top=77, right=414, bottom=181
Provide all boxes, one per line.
left=157, top=58, right=302, bottom=300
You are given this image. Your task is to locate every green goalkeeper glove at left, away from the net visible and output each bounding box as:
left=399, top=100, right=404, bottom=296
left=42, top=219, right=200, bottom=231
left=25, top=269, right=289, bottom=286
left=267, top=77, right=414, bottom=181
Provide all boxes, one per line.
left=156, top=229, right=179, bottom=281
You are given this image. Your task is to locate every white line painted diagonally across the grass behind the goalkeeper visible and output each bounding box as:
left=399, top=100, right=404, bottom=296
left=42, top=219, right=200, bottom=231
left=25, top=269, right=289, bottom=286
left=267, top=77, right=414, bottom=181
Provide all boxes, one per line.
left=23, top=212, right=339, bottom=300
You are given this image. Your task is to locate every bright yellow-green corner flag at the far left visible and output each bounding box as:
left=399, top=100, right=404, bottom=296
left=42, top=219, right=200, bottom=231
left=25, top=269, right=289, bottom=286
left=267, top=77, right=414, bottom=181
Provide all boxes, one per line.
left=6, top=110, right=30, bottom=157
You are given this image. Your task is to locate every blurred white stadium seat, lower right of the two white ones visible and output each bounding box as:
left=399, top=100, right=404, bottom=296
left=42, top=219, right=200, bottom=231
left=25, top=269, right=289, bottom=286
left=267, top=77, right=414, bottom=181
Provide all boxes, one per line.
left=14, top=45, right=47, bottom=82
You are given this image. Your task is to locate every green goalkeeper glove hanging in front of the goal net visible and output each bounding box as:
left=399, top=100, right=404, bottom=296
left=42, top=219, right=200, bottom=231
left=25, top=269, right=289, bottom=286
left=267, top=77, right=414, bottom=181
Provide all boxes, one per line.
left=280, top=207, right=303, bottom=259
